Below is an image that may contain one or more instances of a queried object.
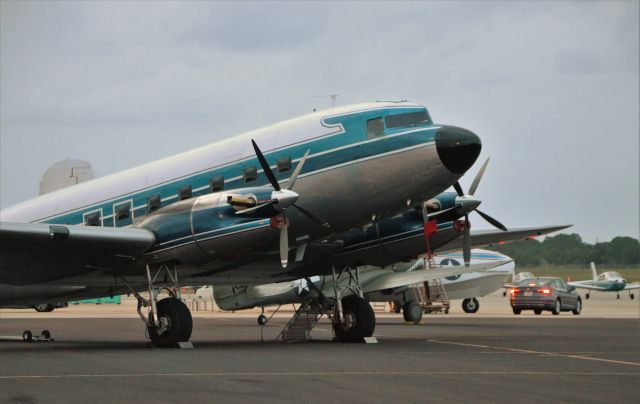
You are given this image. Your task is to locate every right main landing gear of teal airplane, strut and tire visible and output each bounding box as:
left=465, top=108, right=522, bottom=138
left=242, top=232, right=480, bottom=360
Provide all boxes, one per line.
left=331, top=266, right=376, bottom=342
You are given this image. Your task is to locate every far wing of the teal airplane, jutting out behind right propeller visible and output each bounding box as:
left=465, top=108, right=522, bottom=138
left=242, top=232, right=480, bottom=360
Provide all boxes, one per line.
left=436, top=225, right=572, bottom=253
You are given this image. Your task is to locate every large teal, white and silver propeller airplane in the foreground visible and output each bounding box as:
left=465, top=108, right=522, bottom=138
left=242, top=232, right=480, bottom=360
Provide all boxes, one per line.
left=0, top=102, right=490, bottom=346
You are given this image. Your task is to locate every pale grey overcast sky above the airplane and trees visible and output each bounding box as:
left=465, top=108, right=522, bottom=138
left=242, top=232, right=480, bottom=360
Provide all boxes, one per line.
left=0, top=1, right=640, bottom=242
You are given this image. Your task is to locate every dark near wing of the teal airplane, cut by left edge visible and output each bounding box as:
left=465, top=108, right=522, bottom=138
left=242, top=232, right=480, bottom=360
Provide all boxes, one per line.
left=0, top=222, right=155, bottom=285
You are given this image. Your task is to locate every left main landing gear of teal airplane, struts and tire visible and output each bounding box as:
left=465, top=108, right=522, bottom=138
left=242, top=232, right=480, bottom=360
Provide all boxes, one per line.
left=120, top=264, right=193, bottom=348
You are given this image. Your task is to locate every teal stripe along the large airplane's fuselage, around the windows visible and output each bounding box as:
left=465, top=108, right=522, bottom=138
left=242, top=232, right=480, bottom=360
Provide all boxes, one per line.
left=39, top=108, right=437, bottom=227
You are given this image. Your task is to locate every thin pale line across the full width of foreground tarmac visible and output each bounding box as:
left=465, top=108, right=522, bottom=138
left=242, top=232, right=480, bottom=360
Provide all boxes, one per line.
left=0, top=370, right=640, bottom=380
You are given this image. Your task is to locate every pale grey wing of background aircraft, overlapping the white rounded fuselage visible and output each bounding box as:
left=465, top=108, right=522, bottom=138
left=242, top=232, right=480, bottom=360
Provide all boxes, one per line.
left=360, top=260, right=511, bottom=293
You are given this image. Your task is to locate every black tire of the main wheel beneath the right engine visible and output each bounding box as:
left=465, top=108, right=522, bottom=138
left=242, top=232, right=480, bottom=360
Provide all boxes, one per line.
left=333, top=295, right=376, bottom=342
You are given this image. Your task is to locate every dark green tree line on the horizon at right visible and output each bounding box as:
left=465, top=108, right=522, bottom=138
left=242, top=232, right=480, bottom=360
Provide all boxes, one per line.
left=488, top=233, right=640, bottom=267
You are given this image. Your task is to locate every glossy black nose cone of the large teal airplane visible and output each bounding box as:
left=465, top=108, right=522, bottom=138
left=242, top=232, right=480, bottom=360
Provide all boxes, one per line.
left=436, top=126, right=482, bottom=174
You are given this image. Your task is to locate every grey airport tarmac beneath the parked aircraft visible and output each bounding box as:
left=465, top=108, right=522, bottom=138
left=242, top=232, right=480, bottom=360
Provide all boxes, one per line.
left=0, top=295, right=640, bottom=403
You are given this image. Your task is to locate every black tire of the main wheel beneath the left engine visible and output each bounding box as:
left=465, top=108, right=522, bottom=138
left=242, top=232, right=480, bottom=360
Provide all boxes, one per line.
left=147, top=297, right=193, bottom=348
